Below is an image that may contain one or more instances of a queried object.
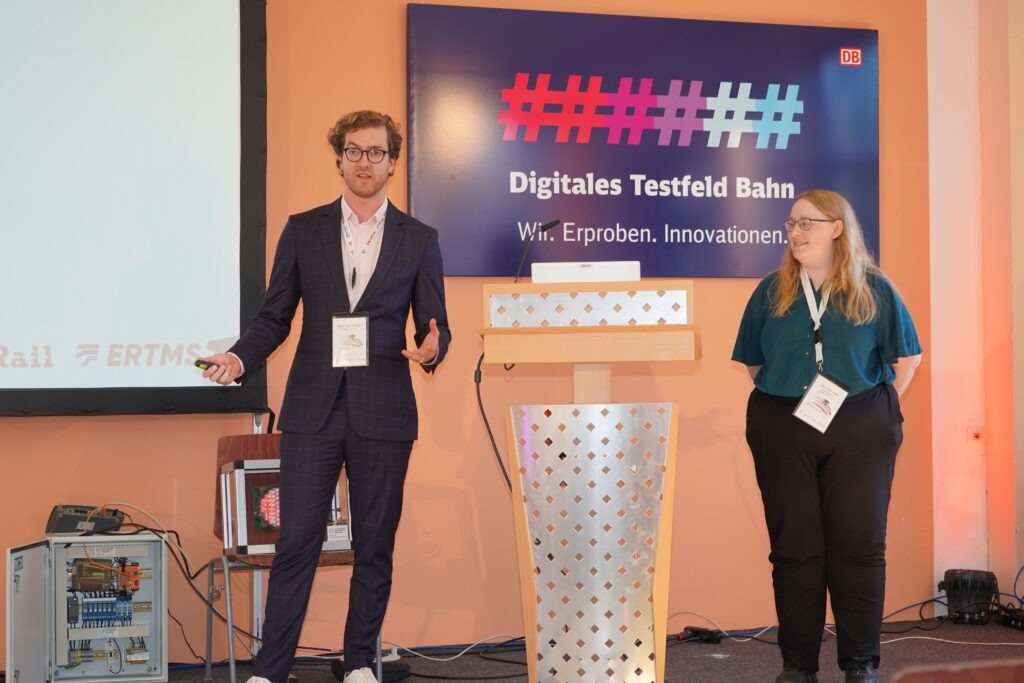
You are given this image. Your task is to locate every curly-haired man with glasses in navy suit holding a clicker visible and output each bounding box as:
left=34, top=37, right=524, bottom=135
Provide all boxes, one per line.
left=203, top=112, right=452, bottom=683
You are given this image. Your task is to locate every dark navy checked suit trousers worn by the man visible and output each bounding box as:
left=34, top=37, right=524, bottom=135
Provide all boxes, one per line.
left=255, top=386, right=413, bottom=683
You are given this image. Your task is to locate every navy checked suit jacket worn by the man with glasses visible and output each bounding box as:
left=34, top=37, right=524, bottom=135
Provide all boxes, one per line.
left=230, top=200, right=452, bottom=441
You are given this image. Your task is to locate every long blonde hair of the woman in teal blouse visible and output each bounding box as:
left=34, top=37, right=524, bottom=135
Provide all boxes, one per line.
left=769, top=189, right=880, bottom=325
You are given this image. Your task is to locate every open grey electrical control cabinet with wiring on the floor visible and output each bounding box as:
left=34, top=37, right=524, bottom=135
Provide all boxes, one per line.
left=6, top=533, right=167, bottom=683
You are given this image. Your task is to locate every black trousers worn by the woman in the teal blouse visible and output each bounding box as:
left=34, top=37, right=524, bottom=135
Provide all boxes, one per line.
left=746, top=384, right=903, bottom=672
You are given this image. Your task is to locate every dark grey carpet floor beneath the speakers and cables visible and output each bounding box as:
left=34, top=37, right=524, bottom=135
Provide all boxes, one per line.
left=170, top=622, right=1024, bottom=683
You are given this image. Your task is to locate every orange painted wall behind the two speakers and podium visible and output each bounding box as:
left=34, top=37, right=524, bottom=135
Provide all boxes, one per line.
left=0, top=0, right=934, bottom=661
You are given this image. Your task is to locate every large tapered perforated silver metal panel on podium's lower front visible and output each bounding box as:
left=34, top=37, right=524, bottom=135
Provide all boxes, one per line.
left=509, top=403, right=672, bottom=683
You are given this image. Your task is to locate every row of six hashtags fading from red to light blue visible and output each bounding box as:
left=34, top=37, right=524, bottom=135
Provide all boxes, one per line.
left=498, top=73, right=804, bottom=150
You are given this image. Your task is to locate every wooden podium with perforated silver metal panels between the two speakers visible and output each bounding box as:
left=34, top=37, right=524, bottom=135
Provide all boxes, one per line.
left=481, top=280, right=700, bottom=683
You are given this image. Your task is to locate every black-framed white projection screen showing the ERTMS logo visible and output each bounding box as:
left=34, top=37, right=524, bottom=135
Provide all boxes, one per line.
left=0, top=0, right=266, bottom=416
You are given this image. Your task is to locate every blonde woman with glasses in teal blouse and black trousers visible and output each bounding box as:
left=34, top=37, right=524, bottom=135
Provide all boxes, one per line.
left=732, top=189, right=921, bottom=683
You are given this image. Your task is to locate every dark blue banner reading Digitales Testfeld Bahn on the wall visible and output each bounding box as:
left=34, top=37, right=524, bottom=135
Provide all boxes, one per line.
left=409, top=4, right=879, bottom=278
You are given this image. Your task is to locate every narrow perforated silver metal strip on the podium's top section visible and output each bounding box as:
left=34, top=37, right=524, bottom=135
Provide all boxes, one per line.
left=489, top=290, right=689, bottom=328
